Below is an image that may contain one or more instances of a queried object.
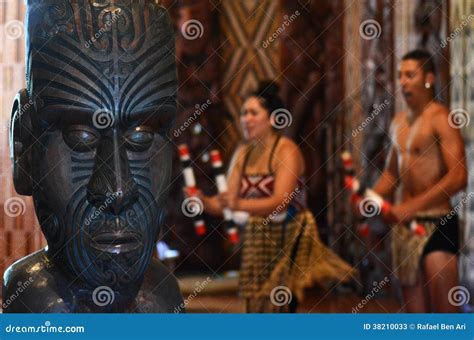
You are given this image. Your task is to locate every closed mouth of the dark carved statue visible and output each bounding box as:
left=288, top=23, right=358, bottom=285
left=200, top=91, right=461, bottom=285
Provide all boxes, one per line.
left=91, top=232, right=142, bottom=254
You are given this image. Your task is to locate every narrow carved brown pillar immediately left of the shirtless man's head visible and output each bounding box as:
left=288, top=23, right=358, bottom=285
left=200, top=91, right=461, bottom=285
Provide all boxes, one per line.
left=354, top=0, right=395, bottom=290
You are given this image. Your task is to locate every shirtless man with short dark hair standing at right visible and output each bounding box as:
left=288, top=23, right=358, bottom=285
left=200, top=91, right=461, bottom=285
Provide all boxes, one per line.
left=368, top=50, right=467, bottom=313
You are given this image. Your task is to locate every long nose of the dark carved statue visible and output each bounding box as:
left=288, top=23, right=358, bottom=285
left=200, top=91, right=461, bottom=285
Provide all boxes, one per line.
left=87, top=129, right=138, bottom=215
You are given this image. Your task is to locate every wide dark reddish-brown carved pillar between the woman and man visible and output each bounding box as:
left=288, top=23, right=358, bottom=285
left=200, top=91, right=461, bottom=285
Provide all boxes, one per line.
left=280, top=0, right=344, bottom=239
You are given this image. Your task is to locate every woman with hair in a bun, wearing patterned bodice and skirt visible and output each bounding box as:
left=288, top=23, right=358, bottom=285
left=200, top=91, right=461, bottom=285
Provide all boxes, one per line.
left=188, top=82, right=355, bottom=313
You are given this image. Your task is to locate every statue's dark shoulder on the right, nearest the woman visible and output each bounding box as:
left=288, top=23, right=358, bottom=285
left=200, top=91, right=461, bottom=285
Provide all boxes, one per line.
left=137, top=259, right=184, bottom=313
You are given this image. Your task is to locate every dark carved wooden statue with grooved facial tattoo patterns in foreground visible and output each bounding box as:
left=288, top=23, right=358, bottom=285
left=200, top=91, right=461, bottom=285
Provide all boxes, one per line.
left=3, top=0, right=182, bottom=313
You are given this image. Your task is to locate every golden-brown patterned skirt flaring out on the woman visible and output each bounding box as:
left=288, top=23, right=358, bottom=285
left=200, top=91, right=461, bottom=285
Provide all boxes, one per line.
left=240, top=210, right=357, bottom=312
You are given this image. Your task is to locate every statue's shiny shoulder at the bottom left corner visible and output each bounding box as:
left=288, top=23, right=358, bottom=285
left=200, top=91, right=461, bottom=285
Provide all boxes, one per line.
left=2, top=250, right=68, bottom=313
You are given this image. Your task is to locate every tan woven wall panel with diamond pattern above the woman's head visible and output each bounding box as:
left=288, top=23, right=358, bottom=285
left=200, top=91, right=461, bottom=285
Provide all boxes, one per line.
left=219, top=0, right=281, bottom=121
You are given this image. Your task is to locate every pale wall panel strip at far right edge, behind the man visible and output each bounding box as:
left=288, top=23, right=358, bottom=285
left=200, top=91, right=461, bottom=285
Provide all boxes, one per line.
left=450, top=0, right=474, bottom=306
